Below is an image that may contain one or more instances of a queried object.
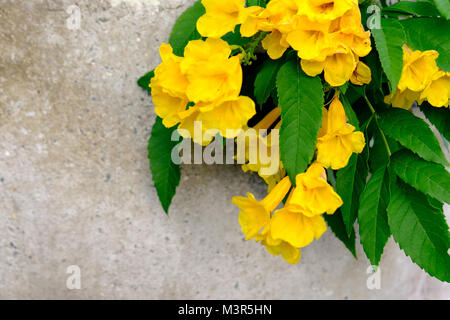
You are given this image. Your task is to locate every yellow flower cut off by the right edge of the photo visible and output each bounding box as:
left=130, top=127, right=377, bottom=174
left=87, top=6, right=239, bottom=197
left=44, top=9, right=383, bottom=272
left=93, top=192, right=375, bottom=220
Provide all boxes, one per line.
left=420, top=70, right=450, bottom=108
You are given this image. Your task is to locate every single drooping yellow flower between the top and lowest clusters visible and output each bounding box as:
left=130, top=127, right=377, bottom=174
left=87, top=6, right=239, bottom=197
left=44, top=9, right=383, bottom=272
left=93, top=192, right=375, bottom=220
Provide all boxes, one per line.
left=317, top=96, right=366, bottom=170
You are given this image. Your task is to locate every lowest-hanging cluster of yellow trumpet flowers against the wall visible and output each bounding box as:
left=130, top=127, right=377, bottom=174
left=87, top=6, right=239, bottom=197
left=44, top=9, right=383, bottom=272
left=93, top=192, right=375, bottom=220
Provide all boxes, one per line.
left=233, top=163, right=343, bottom=264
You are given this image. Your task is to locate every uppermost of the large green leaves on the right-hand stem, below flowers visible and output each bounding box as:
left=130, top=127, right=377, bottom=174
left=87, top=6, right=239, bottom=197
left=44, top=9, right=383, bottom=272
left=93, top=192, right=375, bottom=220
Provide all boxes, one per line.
left=379, top=108, right=448, bottom=166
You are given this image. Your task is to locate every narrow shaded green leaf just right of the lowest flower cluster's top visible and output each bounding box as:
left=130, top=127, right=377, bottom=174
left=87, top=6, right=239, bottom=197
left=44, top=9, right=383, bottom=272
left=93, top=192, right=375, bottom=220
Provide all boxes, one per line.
left=336, top=148, right=369, bottom=235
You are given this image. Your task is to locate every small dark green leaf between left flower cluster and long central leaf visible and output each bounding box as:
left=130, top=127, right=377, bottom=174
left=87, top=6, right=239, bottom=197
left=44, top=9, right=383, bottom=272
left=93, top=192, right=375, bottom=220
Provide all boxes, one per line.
left=254, top=59, right=281, bottom=106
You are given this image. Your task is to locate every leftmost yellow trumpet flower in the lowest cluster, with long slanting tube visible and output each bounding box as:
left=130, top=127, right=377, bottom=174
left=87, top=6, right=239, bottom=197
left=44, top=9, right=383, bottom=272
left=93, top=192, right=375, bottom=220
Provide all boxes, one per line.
left=232, top=177, right=291, bottom=240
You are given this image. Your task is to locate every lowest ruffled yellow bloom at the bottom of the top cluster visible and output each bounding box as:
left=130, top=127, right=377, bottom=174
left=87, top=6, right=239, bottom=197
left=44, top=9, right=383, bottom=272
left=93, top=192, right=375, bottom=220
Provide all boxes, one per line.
left=301, top=45, right=356, bottom=87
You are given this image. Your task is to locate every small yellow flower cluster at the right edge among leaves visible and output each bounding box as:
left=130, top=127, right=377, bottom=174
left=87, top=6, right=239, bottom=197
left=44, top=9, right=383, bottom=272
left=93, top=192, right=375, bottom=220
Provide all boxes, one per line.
left=385, top=45, right=450, bottom=110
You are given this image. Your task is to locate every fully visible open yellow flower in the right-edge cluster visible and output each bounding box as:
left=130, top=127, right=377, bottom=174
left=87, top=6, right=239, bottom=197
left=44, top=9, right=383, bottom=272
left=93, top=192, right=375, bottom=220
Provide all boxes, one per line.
left=398, top=45, right=439, bottom=92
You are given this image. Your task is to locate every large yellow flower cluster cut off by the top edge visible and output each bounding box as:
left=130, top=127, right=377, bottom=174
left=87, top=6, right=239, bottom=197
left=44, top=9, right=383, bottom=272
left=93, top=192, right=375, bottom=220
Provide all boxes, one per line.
left=197, top=0, right=372, bottom=87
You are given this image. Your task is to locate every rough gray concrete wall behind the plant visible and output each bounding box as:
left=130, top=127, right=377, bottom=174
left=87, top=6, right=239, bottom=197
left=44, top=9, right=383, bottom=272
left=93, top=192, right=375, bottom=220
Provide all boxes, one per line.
left=0, top=0, right=450, bottom=299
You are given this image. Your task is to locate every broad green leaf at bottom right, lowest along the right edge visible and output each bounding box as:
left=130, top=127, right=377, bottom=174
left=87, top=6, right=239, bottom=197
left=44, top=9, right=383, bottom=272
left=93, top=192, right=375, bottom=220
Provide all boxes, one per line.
left=388, top=181, right=450, bottom=282
